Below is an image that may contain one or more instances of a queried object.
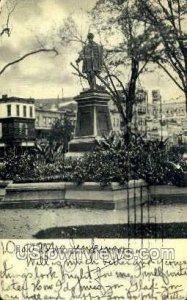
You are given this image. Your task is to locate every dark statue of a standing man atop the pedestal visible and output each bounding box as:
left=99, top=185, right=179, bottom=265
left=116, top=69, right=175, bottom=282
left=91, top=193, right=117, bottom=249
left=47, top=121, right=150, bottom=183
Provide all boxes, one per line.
left=76, top=33, right=103, bottom=90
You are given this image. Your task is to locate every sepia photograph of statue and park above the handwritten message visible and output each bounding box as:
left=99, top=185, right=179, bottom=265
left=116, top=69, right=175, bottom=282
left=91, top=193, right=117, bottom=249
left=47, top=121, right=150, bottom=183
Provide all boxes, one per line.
left=0, top=0, right=187, bottom=238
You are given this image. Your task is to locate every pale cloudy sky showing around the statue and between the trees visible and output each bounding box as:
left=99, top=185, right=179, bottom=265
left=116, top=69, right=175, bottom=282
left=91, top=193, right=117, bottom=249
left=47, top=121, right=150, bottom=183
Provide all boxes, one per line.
left=0, top=0, right=183, bottom=101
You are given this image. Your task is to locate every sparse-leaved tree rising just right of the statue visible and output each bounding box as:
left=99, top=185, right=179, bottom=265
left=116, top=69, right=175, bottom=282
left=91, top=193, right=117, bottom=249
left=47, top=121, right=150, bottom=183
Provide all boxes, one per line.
left=92, top=0, right=159, bottom=131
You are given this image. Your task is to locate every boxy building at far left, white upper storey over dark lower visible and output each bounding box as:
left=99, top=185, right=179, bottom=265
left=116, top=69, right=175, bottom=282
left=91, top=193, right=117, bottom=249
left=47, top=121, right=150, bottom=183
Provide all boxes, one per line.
left=0, top=95, right=35, bottom=147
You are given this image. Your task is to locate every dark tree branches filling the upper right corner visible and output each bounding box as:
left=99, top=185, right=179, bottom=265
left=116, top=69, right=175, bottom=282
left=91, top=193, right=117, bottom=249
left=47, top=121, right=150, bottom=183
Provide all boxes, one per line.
left=136, top=0, right=187, bottom=101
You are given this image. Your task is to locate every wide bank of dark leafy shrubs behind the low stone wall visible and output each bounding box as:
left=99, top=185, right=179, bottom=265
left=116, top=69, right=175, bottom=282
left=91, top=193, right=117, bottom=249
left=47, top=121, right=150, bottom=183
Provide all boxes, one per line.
left=0, top=134, right=187, bottom=186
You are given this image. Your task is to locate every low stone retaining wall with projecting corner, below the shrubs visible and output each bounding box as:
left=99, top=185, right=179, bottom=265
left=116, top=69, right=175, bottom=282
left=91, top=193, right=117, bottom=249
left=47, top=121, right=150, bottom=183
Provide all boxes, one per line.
left=0, top=179, right=148, bottom=209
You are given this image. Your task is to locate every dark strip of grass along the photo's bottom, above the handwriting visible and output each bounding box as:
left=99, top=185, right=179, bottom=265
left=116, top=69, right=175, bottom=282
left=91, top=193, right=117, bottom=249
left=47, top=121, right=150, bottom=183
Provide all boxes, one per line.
left=34, top=223, right=187, bottom=239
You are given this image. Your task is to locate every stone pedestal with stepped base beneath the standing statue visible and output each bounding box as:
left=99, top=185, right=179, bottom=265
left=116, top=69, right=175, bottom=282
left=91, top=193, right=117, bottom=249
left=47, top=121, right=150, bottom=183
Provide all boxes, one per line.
left=69, top=90, right=112, bottom=155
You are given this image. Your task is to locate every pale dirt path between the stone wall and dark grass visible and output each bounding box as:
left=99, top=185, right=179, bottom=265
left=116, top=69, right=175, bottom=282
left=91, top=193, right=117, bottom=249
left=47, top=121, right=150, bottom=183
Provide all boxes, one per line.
left=0, top=204, right=187, bottom=239
